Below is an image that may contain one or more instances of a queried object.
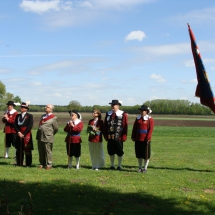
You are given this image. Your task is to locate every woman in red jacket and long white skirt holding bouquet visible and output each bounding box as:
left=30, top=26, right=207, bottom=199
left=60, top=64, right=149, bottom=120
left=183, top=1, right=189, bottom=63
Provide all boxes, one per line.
left=87, top=110, right=105, bottom=170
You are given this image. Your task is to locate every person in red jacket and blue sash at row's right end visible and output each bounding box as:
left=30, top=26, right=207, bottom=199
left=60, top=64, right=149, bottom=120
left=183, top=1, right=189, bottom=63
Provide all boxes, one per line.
left=131, top=105, right=154, bottom=173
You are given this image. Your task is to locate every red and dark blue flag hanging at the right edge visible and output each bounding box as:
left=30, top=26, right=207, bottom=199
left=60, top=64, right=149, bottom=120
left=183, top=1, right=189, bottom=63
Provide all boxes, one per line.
left=188, top=24, right=215, bottom=114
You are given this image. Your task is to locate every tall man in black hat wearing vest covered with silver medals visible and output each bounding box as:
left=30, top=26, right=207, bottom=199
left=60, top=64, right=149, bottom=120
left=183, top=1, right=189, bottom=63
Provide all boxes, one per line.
left=103, top=100, right=128, bottom=170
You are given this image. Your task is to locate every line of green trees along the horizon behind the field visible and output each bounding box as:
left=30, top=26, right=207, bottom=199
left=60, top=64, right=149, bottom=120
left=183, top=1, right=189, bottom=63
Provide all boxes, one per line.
left=0, top=81, right=212, bottom=115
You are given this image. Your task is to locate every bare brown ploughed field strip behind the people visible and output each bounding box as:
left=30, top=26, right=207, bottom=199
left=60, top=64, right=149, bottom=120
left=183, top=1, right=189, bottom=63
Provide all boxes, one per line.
left=0, top=111, right=215, bottom=129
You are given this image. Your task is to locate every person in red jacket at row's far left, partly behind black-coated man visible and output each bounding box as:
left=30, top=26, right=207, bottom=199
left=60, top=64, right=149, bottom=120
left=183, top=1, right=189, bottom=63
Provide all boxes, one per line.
left=2, top=101, right=18, bottom=158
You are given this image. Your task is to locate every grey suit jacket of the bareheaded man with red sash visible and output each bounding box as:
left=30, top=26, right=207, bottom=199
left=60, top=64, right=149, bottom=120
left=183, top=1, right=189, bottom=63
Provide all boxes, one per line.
left=36, top=116, right=58, bottom=143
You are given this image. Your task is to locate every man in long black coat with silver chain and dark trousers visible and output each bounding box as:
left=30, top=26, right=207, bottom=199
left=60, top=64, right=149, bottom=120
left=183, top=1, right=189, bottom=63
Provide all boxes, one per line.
left=15, top=102, right=34, bottom=167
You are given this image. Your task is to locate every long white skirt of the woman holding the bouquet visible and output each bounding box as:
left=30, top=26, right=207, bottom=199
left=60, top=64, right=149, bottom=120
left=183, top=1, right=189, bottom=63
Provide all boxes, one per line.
left=89, top=142, right=105, bottom=168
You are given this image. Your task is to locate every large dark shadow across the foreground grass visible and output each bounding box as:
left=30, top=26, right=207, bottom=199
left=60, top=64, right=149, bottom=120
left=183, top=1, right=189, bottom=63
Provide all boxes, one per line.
left=0, top=179, right=215, bottom=215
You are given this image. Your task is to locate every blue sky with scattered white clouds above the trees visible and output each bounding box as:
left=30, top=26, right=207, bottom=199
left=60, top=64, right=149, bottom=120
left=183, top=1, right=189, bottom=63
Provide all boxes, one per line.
left=0, top=0, right=215, bottom=106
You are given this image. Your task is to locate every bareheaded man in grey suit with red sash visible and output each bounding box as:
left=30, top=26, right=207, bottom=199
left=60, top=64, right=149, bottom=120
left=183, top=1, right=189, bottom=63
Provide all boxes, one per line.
left=36, top=104, right=58, bottom=170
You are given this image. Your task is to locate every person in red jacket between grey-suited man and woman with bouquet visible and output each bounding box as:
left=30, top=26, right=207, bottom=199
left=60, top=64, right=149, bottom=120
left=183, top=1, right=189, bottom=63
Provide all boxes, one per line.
left=64, top=110, right=84, bottom=169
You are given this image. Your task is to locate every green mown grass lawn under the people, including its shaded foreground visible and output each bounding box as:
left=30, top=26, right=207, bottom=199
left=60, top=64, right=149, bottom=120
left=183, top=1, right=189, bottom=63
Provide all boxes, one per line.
left=0, top=126, right=215, bottom=215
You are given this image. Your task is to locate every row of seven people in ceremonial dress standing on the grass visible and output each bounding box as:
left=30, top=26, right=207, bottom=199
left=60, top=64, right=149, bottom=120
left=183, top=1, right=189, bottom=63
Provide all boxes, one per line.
left=2, top=100, right=154, bottom=173
